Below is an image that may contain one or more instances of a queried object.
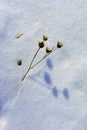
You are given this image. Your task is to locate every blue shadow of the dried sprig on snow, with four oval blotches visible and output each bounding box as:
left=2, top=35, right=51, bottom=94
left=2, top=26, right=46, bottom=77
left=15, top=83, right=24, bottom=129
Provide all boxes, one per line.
left=28, top=59, right=69, bottom=99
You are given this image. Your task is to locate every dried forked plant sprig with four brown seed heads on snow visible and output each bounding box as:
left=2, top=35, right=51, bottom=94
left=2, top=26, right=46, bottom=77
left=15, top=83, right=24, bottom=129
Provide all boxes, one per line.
left=19, top=35, right=63, bottom=81
